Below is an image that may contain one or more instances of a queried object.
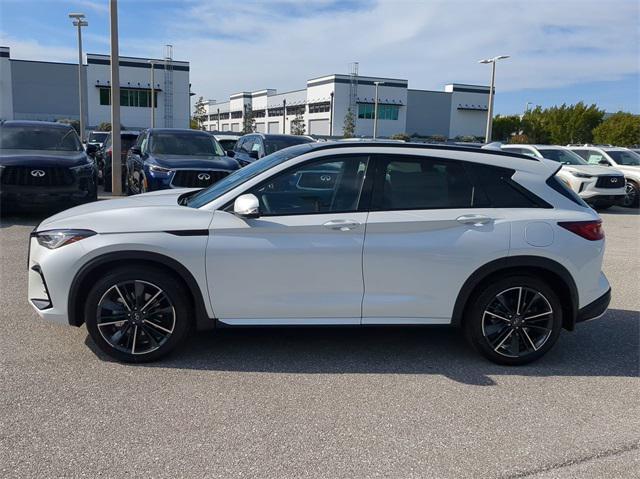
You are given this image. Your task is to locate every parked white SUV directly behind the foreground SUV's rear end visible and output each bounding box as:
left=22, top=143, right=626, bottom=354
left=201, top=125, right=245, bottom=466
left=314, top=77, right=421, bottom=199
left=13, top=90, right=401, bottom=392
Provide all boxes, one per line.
left=502, top=145, right=626, bottom=209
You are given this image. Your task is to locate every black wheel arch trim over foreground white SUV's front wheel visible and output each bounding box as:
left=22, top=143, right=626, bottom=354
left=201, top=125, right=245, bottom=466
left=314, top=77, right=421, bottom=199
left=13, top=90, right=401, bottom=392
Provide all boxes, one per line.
left=67, top=250, right=215, bottom=330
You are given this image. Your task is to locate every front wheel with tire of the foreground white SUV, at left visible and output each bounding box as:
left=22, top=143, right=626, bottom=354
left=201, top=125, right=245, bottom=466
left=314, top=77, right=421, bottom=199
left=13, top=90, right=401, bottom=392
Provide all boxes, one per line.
left=84, top=266, right=192, bottom=363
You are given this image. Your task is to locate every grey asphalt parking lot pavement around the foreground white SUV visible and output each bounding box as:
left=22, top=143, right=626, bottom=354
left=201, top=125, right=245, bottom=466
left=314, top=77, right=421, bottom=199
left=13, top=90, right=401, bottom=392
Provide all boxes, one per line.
left=0, top=208, right=640, bottom=477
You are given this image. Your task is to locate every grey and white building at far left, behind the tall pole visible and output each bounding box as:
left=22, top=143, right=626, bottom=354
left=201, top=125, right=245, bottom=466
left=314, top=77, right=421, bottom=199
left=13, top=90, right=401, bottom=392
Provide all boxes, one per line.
left=0, top=47, right=190, bottom=130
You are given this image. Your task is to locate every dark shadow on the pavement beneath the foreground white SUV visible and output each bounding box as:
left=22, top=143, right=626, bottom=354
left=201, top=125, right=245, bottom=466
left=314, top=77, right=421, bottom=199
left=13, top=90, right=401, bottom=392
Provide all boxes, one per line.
left=86, top=309, right=640, bottom=386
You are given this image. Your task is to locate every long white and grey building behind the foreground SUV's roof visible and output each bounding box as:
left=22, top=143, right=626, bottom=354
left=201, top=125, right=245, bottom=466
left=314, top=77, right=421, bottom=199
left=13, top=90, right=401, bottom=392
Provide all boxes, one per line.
left=204, top=74, right=489, bottom=138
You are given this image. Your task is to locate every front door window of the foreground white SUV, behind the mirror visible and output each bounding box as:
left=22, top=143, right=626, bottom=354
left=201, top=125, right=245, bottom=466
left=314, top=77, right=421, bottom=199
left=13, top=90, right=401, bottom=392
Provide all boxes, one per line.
left=247, top=156, right=369, bottom=216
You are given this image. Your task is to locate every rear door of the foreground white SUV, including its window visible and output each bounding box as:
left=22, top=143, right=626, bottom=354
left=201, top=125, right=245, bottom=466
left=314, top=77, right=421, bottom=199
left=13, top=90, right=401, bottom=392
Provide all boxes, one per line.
left=362, top=155, right=510, bottom=324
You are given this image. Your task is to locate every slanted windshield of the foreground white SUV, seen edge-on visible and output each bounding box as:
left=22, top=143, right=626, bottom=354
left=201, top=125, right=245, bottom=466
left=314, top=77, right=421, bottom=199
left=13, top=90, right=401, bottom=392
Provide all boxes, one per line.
left=184, top=145, right=311, bottom=208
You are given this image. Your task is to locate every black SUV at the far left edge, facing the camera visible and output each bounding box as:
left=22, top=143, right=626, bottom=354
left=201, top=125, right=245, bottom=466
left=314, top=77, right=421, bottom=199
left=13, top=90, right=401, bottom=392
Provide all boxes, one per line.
left=0, top=121, right=98, bottom=207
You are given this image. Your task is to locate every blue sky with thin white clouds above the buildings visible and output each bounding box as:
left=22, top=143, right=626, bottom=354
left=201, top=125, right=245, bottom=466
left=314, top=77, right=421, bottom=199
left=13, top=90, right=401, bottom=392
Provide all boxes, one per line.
left=0, top=0, right=640, bottom=114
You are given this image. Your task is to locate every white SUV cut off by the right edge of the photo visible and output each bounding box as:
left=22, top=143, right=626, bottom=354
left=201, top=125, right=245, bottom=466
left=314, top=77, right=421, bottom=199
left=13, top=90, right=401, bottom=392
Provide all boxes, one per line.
left=570, top=146, right=640, bottom=208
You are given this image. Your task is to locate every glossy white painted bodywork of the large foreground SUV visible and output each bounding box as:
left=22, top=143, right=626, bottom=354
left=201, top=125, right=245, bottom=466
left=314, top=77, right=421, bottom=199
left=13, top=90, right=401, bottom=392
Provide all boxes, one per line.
left=29, top=143, right=609, bottom=342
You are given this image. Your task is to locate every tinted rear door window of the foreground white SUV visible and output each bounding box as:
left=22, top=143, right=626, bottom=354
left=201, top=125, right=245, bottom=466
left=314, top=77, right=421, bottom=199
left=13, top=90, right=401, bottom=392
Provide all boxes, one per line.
left=375, top=158, right=475, bottom=210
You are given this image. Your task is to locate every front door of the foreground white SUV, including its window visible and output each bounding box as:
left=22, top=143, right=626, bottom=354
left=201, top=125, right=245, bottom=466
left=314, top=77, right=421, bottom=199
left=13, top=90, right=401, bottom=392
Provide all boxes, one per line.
left=206, top=155, right=369, bottom=324
